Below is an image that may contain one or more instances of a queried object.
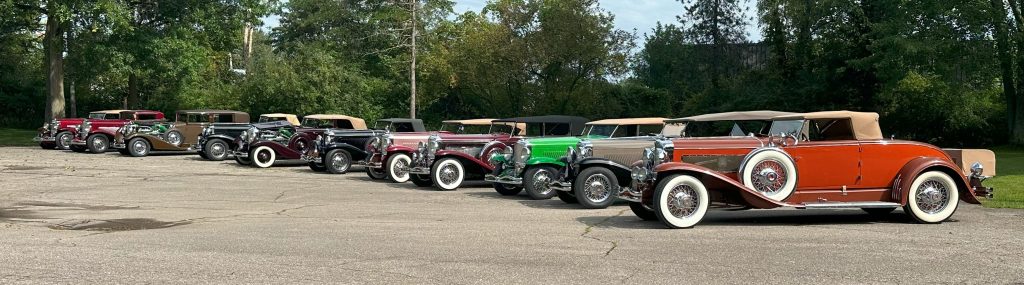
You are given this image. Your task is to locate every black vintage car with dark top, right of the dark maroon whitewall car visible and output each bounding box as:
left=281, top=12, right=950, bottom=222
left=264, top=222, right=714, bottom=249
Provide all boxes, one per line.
left=304, top=118, right=426, bottom=173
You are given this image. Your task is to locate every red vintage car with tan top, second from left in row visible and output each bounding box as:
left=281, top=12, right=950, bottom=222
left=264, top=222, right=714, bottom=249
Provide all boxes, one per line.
left=70, top=110, right=164, bottom=154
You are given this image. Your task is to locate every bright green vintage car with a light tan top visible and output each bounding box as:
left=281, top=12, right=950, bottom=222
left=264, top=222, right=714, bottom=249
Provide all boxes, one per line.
left=484, top=118, right=665, bottom=200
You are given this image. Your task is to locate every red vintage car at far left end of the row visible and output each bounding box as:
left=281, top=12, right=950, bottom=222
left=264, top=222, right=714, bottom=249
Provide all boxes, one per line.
left=32, top=110, right=164, bottom=151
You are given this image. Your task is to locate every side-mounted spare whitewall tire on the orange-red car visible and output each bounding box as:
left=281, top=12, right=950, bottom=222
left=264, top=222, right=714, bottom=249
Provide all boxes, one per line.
left=739, top=150, right=797, bottom=201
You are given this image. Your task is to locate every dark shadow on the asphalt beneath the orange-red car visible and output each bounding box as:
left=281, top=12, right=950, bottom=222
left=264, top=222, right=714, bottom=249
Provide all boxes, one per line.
left=577, top=209, right=917, bottom=229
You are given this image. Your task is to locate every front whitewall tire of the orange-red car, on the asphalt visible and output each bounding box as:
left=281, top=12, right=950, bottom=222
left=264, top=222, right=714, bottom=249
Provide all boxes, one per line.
left=654, top=175, right=711, bottom=229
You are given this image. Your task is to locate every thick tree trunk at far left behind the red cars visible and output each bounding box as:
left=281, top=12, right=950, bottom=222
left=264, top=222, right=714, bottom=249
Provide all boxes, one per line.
left=43, top=1, right=65, bottom=121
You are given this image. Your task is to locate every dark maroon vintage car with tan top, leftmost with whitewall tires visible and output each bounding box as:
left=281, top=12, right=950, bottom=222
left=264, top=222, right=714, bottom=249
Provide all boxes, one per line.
left=231, top=114, right=367, bottom=170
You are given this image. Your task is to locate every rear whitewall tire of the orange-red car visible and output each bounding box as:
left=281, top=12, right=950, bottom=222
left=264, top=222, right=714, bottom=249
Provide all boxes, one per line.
left=903, top=171, right=959, bottom=223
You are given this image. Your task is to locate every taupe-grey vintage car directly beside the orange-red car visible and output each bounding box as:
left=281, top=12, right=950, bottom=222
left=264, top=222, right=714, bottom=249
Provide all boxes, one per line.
left=550, top=111, right=793, bottom=209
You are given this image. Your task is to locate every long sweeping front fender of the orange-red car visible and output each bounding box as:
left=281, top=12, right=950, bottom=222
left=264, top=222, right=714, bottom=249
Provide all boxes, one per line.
left=654, top=162, right=790, bottom=209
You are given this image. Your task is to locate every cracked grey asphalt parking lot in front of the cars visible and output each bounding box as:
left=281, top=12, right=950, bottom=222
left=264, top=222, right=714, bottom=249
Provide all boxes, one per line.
left=0, top=148, right=1024, bottom=284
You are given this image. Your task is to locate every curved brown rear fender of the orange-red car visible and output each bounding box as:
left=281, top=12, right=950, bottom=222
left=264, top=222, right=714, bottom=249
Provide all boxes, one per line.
left=892, top=157, right=981, bottom=205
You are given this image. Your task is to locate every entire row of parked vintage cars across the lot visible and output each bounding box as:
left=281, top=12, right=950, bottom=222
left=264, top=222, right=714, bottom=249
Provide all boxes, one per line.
left=36, top=110, right=995, bottom=228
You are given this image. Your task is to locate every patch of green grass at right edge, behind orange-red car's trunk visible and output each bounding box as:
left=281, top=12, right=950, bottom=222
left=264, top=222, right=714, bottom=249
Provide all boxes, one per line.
left=982, top=147, right=1024, bottom=209
